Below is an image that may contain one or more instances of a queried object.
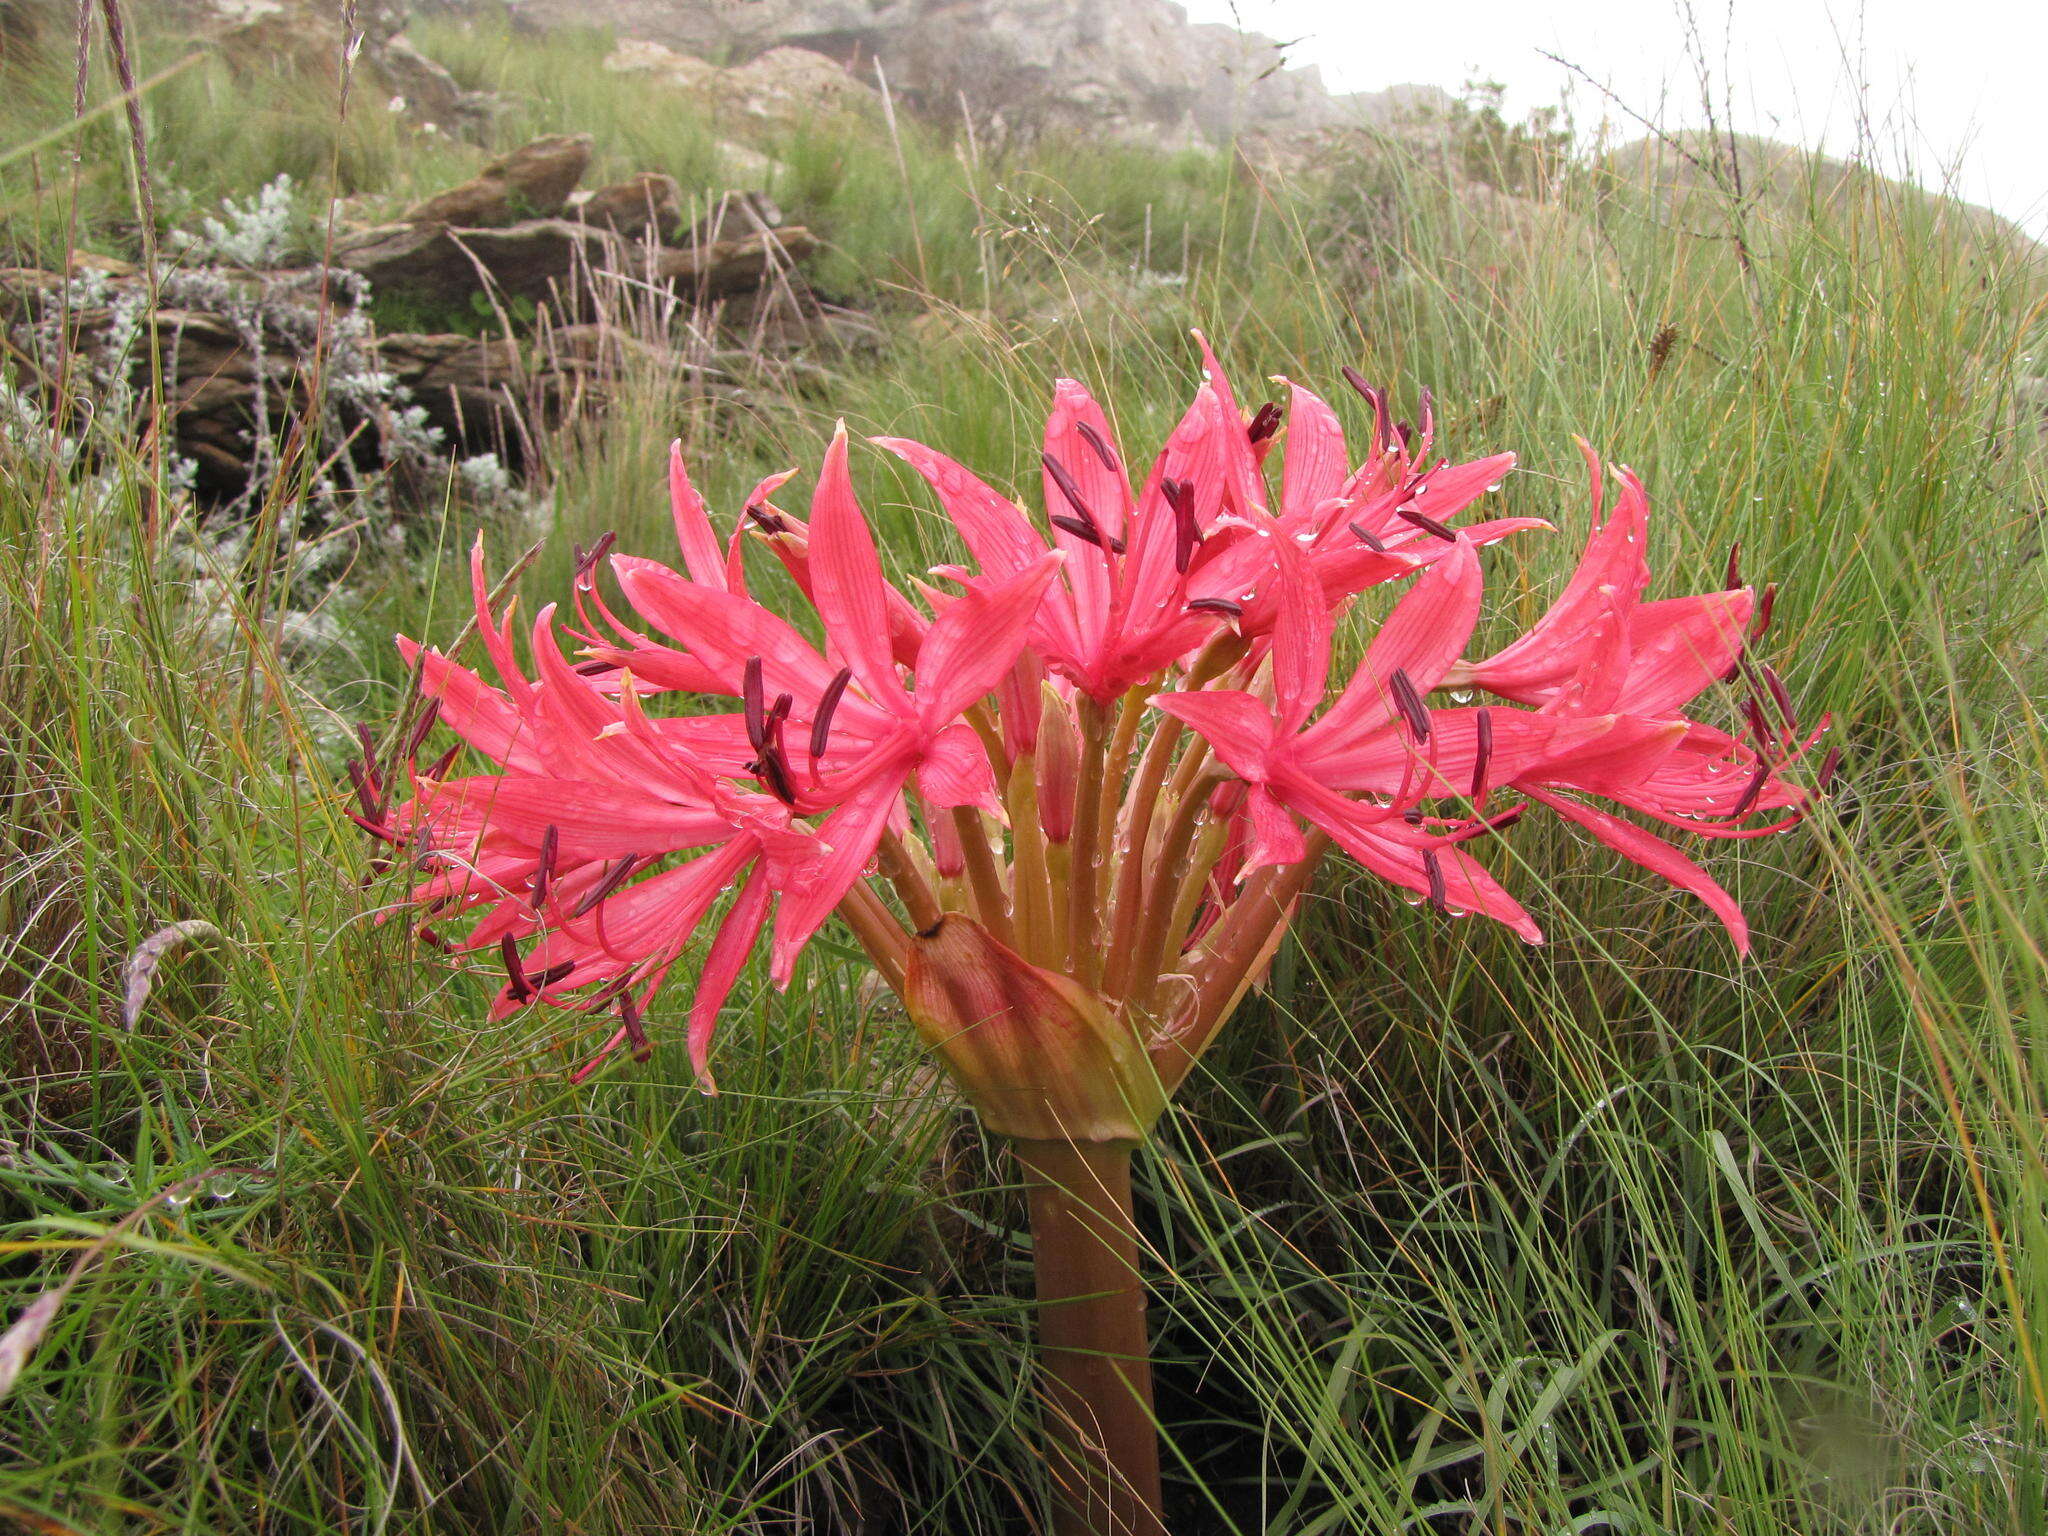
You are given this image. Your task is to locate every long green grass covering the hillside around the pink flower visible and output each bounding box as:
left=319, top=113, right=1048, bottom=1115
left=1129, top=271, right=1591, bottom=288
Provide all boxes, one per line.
left=0, top=12, right=2048, bottom=1536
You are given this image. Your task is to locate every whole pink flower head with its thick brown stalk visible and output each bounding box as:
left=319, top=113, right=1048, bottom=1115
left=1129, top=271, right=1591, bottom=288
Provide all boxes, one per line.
left=354, top=344, right=1827, bottom=1536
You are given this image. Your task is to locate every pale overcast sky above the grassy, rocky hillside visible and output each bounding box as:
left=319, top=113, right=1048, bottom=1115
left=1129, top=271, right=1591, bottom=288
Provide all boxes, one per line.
left=1182, top=0, right=2048, bottom=238
